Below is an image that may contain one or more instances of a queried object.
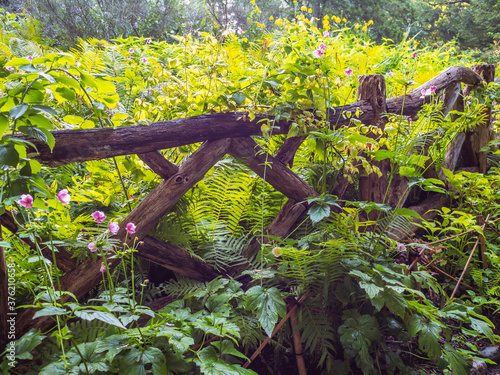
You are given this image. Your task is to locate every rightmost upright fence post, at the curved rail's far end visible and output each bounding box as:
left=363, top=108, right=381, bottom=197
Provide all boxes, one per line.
left=461, top=64, right=495, bottom=174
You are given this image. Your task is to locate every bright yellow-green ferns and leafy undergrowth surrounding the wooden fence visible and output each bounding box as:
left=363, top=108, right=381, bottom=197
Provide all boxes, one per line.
left=0, top=7, right=500, bottom=374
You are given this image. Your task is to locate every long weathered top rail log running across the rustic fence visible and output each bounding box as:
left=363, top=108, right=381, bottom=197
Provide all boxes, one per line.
left=16, top=66, right=482, bottom=166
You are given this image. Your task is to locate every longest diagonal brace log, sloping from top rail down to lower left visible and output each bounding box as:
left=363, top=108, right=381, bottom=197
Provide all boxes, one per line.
left=18, top=139, right=230, bottom=335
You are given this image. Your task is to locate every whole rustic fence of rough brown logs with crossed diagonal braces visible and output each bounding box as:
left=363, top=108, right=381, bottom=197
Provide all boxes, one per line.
left=0, top=65, right=494, bottom=348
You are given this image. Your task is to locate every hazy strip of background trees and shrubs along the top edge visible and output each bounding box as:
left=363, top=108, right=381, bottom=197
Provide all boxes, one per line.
left=1, top=0, right=500, bottom=52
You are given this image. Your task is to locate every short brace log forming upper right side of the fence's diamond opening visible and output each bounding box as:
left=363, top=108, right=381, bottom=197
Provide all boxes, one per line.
left=229, top=137, right=318, bottom=202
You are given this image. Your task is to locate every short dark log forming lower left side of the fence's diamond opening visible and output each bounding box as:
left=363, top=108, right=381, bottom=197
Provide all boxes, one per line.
left=137, top=236, right=220, bottom=281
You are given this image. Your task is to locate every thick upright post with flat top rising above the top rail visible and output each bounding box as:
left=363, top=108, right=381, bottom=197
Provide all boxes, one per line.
left=357, top=74, right=391, bottom=213
